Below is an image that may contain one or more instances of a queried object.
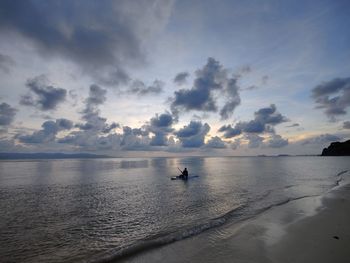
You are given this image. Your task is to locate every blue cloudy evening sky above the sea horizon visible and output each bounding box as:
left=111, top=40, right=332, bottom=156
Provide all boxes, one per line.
left=0, top=0, right=350, bottom=157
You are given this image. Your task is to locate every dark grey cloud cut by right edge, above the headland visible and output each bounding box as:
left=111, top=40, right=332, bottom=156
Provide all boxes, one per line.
left=312, top=78, right=350, bottom=120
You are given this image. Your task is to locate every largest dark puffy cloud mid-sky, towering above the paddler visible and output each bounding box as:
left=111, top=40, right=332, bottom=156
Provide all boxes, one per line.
left=171, top=58, right=241, bottom=119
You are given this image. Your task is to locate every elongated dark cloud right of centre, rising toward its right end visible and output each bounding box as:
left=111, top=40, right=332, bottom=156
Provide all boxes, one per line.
left=218, top=104, right=288, bottom=139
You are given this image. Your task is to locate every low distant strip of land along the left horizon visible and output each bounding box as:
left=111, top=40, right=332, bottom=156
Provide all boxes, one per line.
left=0, top=153, right=111, bottom=160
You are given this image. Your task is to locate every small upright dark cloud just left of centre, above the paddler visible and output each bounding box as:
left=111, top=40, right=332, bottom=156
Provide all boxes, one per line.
left=148, top=112, right=174, bottom=146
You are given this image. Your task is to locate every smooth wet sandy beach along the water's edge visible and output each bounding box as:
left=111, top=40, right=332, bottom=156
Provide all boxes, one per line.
left=124, top=184, right=350, bottom=263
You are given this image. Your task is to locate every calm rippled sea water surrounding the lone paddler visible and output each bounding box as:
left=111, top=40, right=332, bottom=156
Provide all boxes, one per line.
left=0, top=156, right=350, bottom=262
